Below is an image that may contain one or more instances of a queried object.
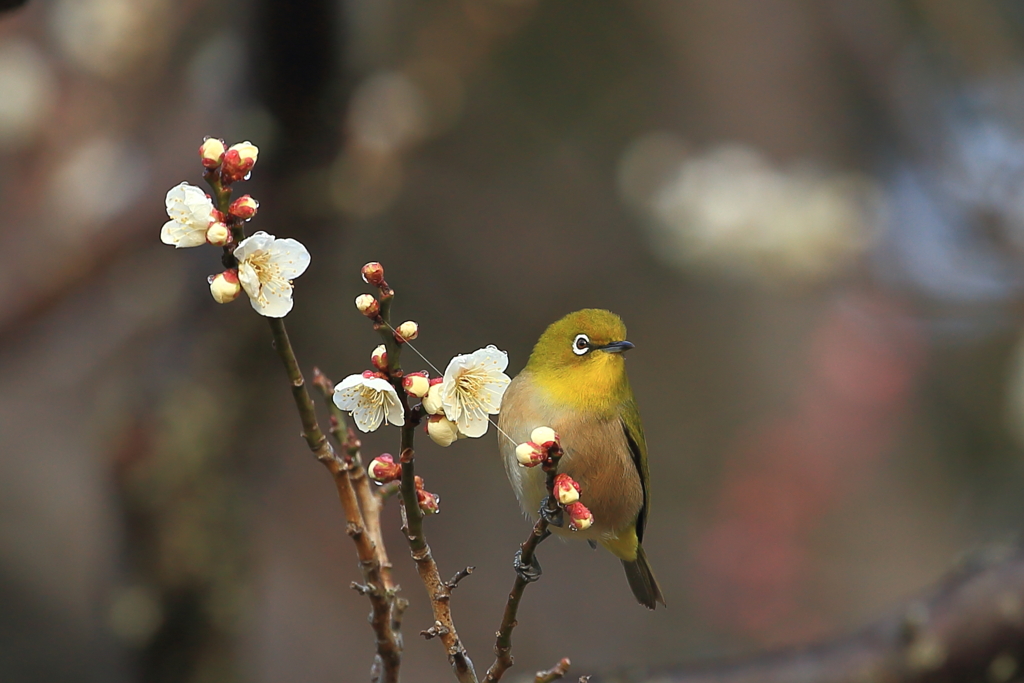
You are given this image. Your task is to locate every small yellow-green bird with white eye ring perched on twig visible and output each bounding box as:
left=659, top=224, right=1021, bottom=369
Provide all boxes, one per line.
left=498, top=308, right=666, bottom=609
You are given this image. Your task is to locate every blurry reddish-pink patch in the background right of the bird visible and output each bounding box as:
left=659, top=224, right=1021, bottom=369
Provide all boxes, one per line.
left=694, top=295, right=925, bottom=644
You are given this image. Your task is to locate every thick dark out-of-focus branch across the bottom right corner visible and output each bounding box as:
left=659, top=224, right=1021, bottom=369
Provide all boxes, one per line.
left=594, top=549, right=1024, bottom=683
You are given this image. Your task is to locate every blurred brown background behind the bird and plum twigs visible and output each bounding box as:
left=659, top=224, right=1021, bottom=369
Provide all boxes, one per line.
left=0, top=0, right=1024, bottom=683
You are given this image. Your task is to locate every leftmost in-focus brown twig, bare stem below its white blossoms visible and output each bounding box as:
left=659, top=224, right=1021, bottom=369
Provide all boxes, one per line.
left=268, top=317, right=403, bottom=683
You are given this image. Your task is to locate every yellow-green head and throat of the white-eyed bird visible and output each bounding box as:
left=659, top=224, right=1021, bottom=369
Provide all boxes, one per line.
left=526, top=308, right=633, bottom=412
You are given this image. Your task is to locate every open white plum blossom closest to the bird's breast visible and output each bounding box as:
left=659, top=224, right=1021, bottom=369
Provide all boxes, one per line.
left=440, top=346, right=512, bottom=438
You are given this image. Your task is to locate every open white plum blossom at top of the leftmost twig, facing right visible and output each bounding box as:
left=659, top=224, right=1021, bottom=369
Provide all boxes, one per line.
left=234, top=230, right=309, bottom=317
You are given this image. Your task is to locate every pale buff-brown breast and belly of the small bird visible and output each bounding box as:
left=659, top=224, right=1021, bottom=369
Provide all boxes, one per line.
left=498, top=371, right=643, bottom=539
